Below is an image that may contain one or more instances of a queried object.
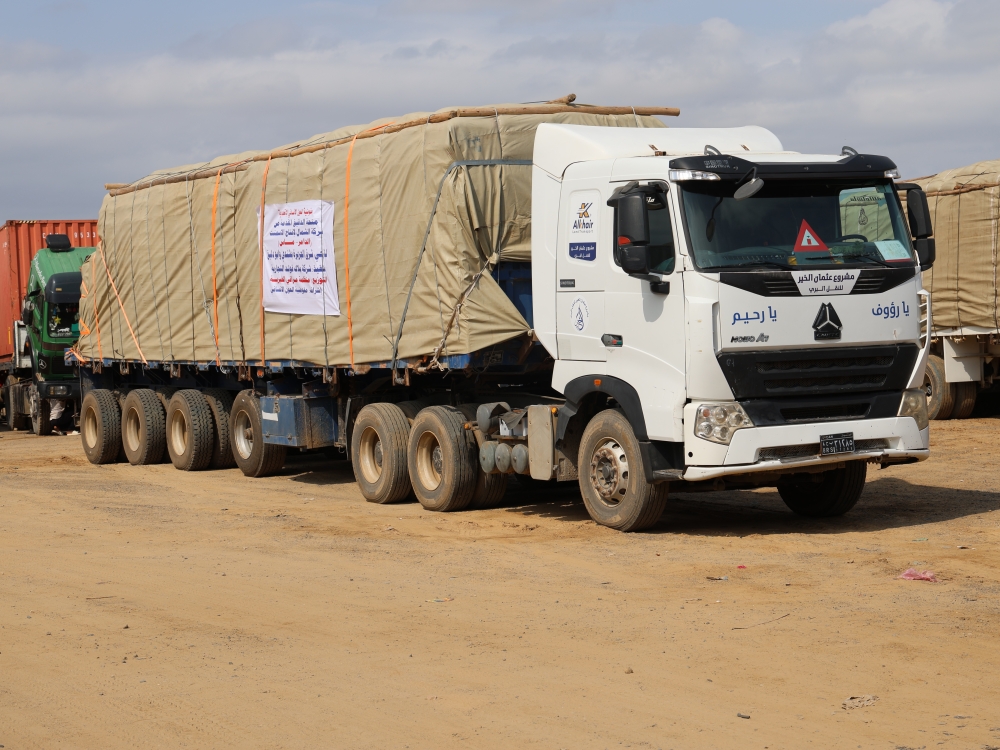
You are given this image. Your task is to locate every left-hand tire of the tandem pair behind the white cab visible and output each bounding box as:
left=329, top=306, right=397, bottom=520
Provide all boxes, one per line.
left=351, top=404, right=413, bottom=504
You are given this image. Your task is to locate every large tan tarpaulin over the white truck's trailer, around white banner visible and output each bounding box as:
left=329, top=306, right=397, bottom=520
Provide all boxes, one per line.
left=78, top=104, right=664, bottom=366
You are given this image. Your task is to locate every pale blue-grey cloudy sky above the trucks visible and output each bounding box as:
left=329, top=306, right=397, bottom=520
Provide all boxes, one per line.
left=0, top=0, right=1000, bottom=221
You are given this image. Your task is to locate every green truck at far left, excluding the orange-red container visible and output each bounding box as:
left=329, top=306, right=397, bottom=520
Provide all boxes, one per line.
left=0, top=234, right=95, bottom=435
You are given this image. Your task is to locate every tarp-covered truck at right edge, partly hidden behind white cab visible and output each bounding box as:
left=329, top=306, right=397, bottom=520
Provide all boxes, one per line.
left=902, top=160, right=1000, bottom=419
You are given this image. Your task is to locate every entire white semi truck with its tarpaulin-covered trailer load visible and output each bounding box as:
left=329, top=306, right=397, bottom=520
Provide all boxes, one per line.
left=69, top=103, right=933, bottom=531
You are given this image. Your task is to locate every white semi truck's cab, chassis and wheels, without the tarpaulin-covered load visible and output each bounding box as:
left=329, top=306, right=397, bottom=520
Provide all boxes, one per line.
left=77, top=116, right=934, bottom=531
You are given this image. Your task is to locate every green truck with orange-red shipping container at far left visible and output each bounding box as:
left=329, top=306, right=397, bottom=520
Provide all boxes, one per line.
left=0, top=220, right=97, bottom=435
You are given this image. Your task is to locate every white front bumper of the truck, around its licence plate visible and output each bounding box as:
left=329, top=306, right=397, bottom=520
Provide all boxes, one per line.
left=684, top=415, right=930, bottom=481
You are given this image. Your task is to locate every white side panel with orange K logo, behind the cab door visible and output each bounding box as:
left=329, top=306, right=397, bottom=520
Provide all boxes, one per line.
left=556, top=181, right=613, bottom=362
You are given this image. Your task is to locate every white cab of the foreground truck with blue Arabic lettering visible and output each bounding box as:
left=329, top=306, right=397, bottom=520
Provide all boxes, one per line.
left=532, top=124, right=930, bottom=515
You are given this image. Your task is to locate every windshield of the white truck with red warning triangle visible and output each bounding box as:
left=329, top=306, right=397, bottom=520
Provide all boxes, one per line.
left=681, top=177, right=914, bottom=270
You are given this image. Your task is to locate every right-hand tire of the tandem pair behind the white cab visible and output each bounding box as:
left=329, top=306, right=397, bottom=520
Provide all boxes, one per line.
left=406, top=406, right=480, bottom=512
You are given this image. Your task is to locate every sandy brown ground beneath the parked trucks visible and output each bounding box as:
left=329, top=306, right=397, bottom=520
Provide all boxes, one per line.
left=0, top=408, right=1000, bottom=749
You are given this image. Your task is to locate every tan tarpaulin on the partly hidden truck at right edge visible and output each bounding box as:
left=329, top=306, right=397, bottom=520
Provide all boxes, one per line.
left=908, top=160, right=1000, bottom=330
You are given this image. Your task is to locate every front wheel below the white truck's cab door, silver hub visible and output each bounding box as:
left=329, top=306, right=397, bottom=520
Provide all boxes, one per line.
left=578, top=409, right=668, bottom=531
